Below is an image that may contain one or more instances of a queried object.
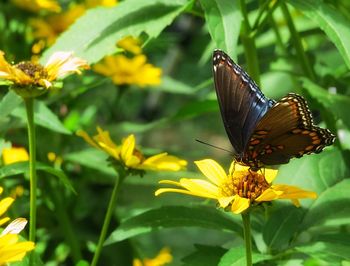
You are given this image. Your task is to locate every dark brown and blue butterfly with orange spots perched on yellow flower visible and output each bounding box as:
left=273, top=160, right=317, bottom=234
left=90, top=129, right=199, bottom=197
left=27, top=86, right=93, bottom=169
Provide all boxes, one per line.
left=213, top=50, right=335, bottom=170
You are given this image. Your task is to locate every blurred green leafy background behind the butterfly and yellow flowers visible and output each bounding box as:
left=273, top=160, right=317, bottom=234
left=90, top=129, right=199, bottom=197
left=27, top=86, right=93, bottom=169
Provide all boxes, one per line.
left=0, top=0, right=350, bottom=266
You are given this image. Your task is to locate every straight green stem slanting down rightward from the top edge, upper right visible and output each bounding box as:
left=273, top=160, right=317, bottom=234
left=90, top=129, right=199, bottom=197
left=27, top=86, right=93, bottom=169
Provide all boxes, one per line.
left=280, top=2, right=316, bottom=81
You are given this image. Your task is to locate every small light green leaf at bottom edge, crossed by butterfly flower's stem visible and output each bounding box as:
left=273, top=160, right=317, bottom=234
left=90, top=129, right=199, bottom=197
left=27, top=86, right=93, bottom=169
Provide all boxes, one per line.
left=218, top=245, right=271, bottom=266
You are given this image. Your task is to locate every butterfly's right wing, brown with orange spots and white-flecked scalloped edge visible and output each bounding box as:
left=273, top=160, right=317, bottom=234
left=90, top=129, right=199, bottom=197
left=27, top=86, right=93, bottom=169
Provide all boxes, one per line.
left=246, top=93, right=335, bottom=165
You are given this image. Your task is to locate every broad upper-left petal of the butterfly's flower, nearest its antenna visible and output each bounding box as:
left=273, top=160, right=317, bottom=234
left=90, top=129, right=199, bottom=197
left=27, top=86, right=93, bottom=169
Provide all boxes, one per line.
left=195, top=159, right=227, bottom=185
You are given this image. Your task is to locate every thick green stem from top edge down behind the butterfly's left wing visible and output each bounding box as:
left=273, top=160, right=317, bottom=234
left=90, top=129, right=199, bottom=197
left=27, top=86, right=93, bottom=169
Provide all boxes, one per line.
left=240, top=0, right=260, bottom=85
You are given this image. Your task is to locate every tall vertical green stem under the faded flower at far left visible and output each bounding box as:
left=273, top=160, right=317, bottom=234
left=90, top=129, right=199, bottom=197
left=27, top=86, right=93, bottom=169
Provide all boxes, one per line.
left=24, top=98, right=37, bottom=265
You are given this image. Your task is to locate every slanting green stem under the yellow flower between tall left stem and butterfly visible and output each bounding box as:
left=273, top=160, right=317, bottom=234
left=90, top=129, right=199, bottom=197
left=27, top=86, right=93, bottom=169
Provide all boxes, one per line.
left=91, top=171, right=126, bottom=266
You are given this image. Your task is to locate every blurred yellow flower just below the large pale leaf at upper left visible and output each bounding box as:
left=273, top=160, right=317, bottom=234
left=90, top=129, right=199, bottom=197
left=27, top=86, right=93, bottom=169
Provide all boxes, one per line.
left=93, top=55, right=162, bottom=87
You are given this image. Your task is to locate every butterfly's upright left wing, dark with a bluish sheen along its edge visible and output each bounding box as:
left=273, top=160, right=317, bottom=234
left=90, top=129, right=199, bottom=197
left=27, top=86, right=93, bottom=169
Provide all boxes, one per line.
left=213, top=50, right=275, bottom=156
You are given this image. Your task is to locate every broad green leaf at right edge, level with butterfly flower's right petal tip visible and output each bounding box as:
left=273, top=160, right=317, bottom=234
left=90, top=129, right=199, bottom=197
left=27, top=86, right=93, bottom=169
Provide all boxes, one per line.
left=301, top=179, right=350, bottom=229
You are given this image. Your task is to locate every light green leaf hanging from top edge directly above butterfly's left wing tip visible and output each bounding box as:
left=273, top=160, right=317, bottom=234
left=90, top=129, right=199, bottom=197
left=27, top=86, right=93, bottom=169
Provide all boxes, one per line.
left=200, top=0, right=242, bottom=59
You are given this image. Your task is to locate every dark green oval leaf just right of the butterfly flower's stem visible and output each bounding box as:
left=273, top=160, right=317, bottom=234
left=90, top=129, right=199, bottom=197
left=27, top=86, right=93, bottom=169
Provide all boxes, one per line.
left=263, top=205, right=303, bottom=250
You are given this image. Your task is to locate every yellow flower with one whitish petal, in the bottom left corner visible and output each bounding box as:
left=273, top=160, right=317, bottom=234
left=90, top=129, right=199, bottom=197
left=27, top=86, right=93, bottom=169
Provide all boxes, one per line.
left=0, top=218, right=34, bottom=265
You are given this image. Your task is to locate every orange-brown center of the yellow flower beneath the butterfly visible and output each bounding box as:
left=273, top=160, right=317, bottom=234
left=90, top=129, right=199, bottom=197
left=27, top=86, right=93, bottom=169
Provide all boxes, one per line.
left=221, top=171, right=270, bottom=201
